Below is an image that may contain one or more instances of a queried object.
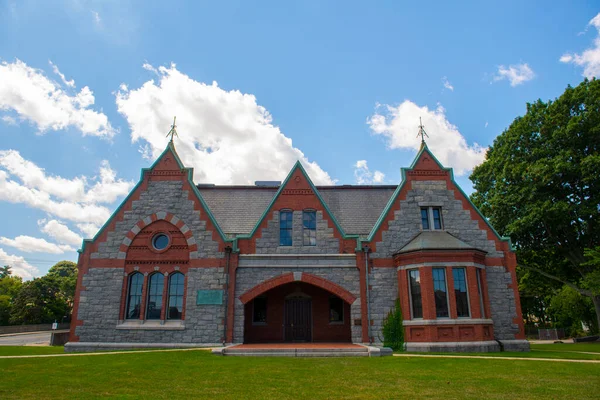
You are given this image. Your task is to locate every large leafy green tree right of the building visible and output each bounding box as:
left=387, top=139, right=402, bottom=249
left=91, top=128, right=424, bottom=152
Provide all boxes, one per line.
left=471, top=79, right=600, bottom=332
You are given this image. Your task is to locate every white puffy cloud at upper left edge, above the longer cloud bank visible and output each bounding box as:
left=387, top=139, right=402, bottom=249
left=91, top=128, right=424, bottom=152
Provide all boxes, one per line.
left=0, top=59, right=115, bottom=137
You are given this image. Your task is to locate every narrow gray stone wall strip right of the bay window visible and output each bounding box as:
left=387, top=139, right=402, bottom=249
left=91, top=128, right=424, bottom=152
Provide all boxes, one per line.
left=485, top=266, right=519, bottom=340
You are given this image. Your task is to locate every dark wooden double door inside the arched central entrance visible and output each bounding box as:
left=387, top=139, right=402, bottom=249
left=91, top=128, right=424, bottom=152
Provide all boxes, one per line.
left=283, top=298, right=312, bottom=342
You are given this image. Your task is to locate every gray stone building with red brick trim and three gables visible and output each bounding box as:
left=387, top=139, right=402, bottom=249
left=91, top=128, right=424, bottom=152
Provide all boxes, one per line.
left=66, top=142, right=528, bottom=351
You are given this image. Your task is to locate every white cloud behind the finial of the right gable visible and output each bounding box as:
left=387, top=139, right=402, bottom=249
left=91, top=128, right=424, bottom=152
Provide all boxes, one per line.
left=367, top=100, right=486, bottom=175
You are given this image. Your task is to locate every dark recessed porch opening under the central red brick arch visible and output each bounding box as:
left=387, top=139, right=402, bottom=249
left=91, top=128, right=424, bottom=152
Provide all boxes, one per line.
left=244, top=282, right=352, bottom=343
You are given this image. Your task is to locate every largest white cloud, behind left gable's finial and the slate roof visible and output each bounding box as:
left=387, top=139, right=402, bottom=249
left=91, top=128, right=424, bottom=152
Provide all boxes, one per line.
left=116, top=64, right=333, bottom=184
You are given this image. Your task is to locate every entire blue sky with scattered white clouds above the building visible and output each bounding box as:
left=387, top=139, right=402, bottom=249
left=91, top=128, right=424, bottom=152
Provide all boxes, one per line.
left=0, top=0, right=600, bottom=278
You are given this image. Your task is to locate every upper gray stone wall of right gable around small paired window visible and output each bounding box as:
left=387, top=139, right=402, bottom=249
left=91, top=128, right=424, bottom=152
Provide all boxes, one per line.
left=372, top=181, right=504, bottom=258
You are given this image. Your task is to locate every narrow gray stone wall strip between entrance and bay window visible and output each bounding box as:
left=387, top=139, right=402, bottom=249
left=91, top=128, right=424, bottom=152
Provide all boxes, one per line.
left=369, top=268, right=398, bottom=344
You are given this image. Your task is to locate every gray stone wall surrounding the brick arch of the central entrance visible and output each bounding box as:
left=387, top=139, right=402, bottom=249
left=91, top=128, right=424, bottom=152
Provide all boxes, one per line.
left=233, top=267, right=362, bottom=343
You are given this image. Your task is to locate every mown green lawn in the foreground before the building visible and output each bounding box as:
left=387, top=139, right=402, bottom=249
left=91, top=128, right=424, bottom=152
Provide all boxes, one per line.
left=0, top=350, right=600, bottom=399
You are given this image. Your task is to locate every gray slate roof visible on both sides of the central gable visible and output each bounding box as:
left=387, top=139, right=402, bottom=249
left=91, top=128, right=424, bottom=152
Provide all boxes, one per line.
left=198, top=185, right=396, bottom=237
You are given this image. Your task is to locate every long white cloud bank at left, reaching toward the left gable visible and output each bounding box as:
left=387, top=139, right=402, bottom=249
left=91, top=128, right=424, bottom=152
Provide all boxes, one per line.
left=0, top=150, right=133, bottom=225
